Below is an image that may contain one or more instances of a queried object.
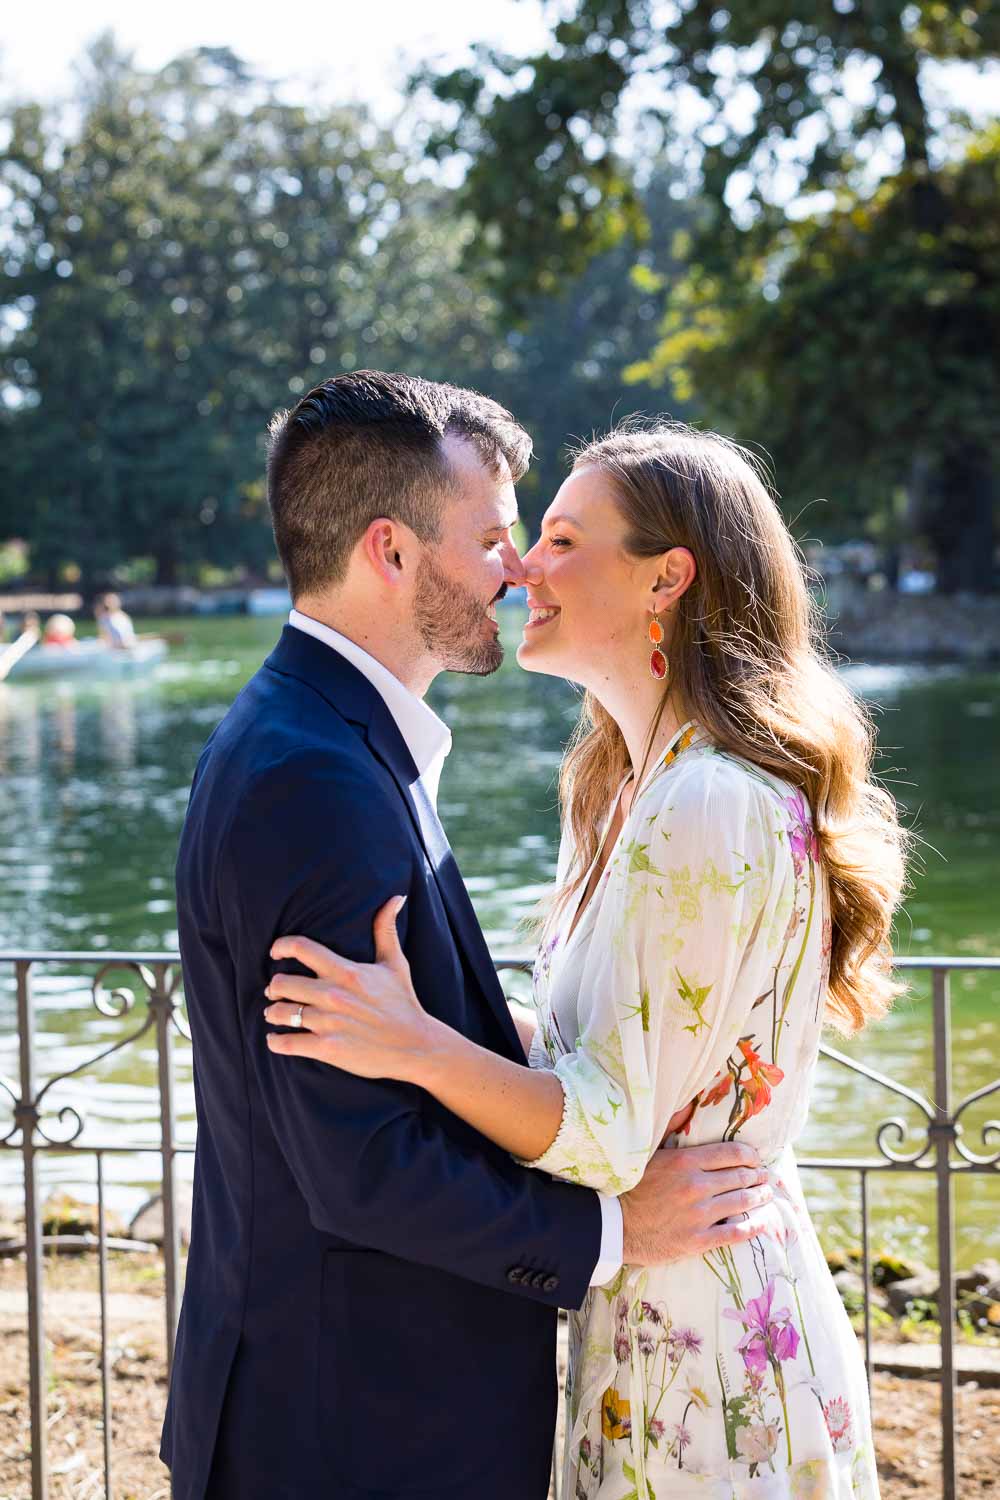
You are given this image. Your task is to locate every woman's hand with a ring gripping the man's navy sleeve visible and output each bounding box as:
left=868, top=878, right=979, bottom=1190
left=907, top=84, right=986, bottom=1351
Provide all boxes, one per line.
left=264, top=896, right=447, bottom=1083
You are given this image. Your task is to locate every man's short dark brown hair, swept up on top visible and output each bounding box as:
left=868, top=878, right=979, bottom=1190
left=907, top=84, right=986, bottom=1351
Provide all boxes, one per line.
left=267, top=371, right=531, bottom=599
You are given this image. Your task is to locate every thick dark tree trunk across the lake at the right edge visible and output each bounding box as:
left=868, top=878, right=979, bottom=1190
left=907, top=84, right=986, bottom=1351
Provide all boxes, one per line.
left=925, top=444, right=996, bottom=594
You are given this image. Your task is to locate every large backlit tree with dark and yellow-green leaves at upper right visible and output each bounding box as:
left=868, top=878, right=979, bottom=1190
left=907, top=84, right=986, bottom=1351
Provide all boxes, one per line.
left=419, top=0, right=1000, bottom=588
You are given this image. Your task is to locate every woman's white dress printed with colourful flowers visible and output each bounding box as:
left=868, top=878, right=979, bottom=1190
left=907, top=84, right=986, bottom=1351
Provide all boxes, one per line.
left=531, top=726, right=879, bottom=1500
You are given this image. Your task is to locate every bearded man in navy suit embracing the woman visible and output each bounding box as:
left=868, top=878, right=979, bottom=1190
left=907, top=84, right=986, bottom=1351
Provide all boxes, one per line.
left=162, top=372, right=768, bottom=1500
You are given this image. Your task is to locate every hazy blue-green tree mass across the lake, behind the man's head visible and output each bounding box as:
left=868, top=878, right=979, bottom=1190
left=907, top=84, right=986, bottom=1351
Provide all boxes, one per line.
left=0, top=39, right=512, bottom=585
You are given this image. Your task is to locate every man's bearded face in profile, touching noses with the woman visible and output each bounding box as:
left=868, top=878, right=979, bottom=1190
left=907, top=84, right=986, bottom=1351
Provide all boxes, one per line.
left=414, top=437, right=523, bottom=677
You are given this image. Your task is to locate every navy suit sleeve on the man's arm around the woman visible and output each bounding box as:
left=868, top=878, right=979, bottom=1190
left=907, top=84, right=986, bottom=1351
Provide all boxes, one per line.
left=219, top=755, right=601, bottom=1307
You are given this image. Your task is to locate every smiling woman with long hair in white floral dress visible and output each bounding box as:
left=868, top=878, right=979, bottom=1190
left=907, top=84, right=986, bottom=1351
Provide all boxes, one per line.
left=265, top=426, right=903, bottom=1500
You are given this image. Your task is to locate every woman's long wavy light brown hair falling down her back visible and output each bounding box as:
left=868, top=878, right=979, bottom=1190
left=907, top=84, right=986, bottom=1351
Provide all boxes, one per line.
left=556, top=419, right=907, bottom=1032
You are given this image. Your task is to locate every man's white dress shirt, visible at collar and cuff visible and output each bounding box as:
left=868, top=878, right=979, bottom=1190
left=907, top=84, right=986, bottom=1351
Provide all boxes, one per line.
left=288, top=609, right=624, bottom=1287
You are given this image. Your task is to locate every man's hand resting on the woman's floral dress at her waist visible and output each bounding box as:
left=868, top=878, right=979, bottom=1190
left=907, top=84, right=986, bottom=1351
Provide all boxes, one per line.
left=619, top=1142, right=774, bottom=1266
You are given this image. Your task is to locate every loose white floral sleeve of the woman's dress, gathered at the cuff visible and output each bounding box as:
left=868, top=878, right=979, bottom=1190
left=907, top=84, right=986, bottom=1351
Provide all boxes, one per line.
left=529, top=755, right=796, bottom=1194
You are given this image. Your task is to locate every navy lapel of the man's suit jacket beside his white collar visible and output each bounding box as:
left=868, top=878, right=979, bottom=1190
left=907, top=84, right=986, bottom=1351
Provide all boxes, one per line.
left=265, top=626, right=523, bottom=1058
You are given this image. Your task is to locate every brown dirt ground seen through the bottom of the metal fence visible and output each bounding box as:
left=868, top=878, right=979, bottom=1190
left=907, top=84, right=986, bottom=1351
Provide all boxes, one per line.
left=0, top=1256, right=1000, bottom=1500
